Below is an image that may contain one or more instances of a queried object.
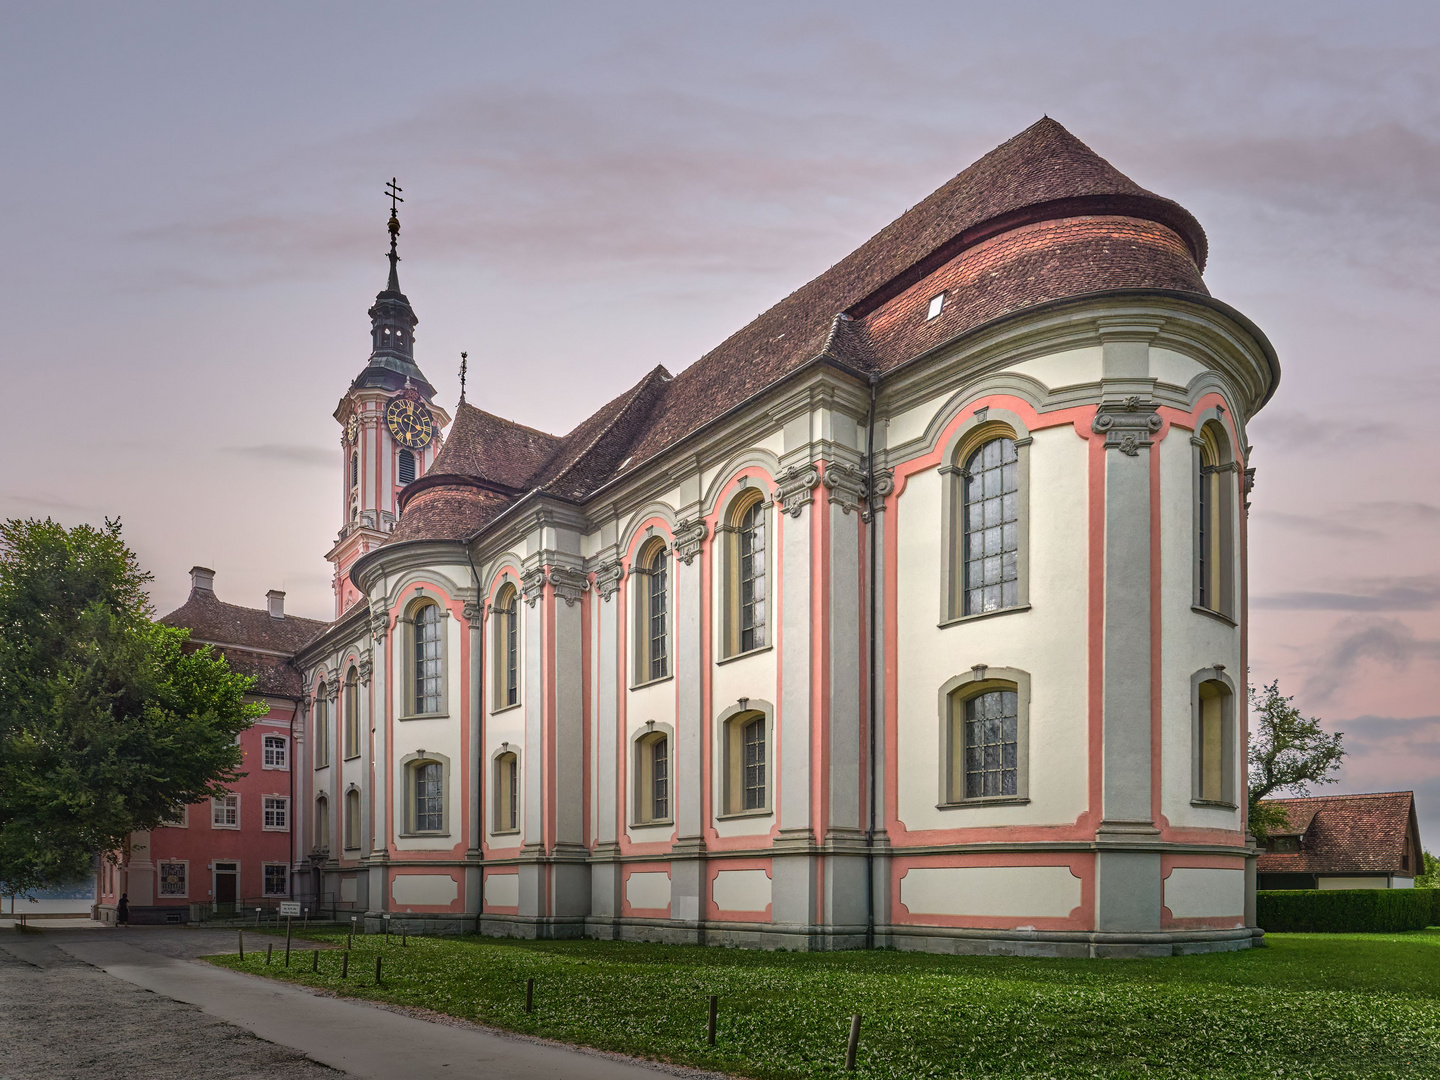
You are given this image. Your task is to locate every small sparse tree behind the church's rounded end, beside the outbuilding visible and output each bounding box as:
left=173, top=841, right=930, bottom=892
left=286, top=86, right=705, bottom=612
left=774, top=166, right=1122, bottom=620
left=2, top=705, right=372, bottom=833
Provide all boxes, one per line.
left=1250, top=680, right=1345, bottom=841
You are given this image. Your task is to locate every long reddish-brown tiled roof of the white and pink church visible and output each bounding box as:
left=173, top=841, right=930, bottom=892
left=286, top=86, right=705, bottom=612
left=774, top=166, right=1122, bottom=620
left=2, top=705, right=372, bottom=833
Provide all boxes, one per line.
left=390, top=118, right=1208, bottom=543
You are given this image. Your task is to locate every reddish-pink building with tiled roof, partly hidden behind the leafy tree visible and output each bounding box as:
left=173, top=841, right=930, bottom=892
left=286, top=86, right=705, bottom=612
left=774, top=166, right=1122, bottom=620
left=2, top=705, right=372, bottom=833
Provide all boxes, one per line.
left=98, top=576, right=325, bottom=923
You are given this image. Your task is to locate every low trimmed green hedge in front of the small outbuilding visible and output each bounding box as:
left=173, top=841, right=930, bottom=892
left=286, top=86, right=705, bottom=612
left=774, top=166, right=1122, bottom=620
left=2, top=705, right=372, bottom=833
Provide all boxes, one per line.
left=1256, top=888, right=1440, bottom=933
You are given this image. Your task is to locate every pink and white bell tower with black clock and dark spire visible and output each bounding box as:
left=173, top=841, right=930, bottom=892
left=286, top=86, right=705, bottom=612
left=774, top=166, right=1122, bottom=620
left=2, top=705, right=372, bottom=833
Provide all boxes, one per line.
left=325, top=180, right=451, bottom=618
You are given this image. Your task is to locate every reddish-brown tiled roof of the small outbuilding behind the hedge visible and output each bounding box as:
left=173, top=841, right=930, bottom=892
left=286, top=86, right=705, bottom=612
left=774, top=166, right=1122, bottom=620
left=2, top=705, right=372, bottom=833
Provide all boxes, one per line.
left=1259, top=791, right=1420, bottom=876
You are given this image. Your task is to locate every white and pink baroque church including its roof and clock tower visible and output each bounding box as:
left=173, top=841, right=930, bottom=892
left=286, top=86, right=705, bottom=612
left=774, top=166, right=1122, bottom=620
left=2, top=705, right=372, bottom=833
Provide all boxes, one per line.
left=163, top=120, right=1279, bottom=956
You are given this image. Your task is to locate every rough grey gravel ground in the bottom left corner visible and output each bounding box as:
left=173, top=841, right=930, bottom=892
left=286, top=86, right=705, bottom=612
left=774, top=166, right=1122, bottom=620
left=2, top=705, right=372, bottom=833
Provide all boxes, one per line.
left=0, top=930, right=346, bottom=1080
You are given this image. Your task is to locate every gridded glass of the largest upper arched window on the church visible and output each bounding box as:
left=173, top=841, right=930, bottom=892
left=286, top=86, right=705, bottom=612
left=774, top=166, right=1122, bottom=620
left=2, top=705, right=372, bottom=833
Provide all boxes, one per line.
left=962, top=438, right=1020, bottom=615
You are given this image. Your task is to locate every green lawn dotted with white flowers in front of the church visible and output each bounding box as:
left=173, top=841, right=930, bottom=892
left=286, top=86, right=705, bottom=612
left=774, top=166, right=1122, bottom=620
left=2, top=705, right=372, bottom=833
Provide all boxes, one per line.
left=215, top=930, right=1440, bottom=1080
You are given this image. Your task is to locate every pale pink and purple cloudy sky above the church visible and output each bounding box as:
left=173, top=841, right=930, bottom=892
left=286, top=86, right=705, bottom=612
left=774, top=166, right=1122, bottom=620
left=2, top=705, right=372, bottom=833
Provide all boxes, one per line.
left=0, top=1, right=1440, bottom=850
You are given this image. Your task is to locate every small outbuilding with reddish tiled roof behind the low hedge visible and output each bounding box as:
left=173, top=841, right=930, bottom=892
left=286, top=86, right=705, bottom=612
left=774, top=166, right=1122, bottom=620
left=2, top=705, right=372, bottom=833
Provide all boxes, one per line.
left=1259, top=791, right=1424, bottom=888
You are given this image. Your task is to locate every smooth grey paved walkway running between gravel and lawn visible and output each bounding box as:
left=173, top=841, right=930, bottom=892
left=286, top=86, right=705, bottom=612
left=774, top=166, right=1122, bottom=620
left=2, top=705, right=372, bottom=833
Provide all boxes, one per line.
left=14, top=927, right=700, bottom=1080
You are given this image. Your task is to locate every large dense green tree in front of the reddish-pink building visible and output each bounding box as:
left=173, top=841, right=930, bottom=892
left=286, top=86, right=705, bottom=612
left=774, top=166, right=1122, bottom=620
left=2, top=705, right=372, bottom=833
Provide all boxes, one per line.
left=0, top=520, right=265, bottom=893
